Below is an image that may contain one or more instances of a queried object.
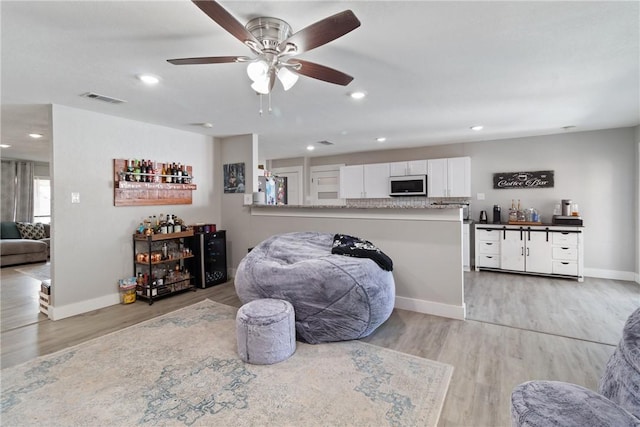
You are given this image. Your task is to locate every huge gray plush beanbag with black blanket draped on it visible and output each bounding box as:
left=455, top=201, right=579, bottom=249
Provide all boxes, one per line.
left=235, top=232, right=395, bottom=344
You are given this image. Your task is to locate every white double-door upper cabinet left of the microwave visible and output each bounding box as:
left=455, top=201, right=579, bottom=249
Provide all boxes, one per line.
left=340, top=163, right=389, bottom=199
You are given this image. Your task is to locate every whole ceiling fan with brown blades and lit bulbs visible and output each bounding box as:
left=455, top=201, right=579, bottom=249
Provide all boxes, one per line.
left=167, top=0, right=360, bottom=95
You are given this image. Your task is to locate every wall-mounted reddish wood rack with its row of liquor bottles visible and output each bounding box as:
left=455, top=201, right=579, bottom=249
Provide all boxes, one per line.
left=113, top=159, right=197, bottom=206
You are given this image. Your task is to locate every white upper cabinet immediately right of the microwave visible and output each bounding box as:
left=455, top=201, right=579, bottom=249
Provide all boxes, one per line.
left=427, top=157, right=471, bottom=197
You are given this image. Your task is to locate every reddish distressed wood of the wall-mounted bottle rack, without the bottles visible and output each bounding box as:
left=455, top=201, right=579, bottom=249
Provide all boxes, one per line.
left=113, top=159, right=197, bottom=206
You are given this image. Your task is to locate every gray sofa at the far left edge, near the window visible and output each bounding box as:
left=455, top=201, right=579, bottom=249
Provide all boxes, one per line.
left=0, top=221, right=51, bottom=267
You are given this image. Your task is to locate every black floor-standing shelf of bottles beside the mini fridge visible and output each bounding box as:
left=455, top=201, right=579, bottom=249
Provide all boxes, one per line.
left=133, top=229, right=196, bottom=305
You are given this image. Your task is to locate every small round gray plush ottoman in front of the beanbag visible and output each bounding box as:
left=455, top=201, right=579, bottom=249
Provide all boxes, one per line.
left=236, top=298, right=296, bottom=365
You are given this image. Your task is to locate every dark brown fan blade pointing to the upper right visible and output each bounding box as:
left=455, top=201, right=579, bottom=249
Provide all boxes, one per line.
left=278, top=10, right=360, bottom=53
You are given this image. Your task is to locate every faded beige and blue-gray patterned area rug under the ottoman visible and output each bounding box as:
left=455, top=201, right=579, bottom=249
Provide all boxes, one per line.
left=1, top=300, right=453, bottom=426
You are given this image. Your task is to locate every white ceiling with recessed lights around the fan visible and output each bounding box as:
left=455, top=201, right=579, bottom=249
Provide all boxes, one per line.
left=0, top=0, right=640, bottom=164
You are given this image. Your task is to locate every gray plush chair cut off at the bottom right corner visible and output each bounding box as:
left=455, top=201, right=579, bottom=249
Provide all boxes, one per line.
left=511, top=308, right=640, bottom=427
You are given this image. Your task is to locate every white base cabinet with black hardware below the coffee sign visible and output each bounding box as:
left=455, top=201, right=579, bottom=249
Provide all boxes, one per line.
left=475, top=224, right=584, bottom=282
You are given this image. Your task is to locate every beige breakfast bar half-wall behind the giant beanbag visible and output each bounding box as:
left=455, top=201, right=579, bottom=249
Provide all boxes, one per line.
left=247, top=205, right=465, bottom=319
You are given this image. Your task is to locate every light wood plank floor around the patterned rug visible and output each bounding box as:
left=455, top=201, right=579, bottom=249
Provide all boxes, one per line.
left=0, top=268, right=640, bottom=427
